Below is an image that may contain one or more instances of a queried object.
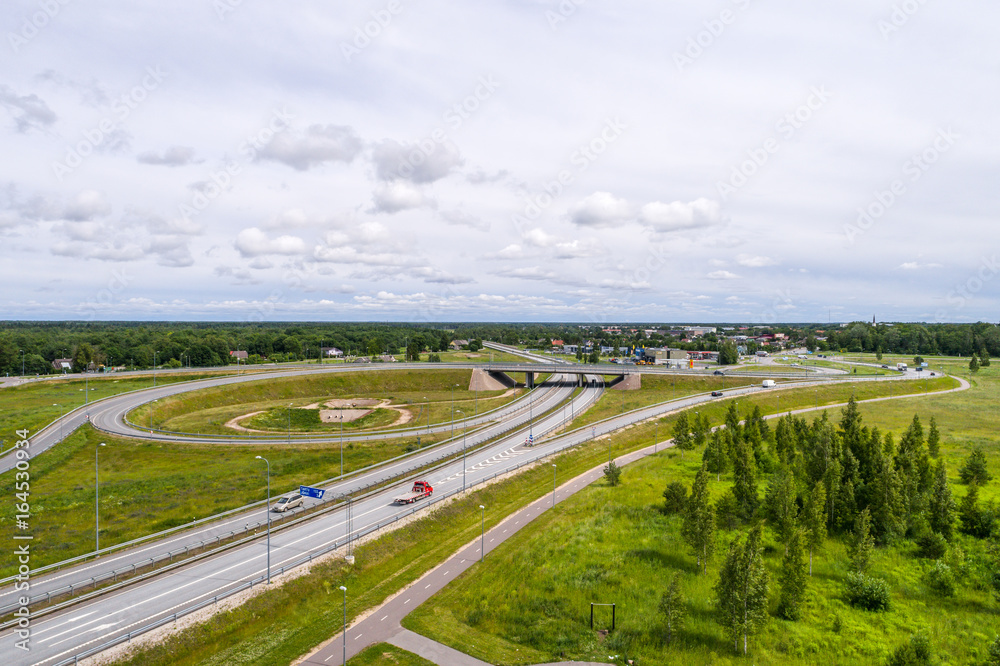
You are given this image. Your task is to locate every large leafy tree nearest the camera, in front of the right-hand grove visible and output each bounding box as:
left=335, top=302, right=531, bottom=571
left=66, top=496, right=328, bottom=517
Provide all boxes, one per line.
left=715, top=523, right=768, bottom=654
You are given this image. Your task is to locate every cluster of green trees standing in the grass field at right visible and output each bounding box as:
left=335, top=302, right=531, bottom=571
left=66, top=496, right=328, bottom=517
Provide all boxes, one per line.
left=660, top=398, right=1000, bottom=653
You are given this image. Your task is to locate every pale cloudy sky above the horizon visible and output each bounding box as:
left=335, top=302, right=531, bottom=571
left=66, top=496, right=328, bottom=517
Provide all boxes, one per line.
left=0, top=0, right=1000, bottom=323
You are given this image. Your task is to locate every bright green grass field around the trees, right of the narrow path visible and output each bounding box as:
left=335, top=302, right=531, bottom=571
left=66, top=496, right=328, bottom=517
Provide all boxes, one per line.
left=404, top=373, right=1000, bottom=666
